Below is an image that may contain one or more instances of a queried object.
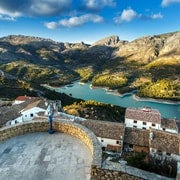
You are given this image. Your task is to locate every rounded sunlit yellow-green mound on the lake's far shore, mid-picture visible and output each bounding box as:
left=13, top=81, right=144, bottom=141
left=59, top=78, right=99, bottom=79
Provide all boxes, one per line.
left=92, top=73, right=127, bottom=89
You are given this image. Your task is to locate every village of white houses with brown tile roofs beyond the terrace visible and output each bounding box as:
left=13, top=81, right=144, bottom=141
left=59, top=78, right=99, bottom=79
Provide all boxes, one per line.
left=0, top=96, right=180, bottom=179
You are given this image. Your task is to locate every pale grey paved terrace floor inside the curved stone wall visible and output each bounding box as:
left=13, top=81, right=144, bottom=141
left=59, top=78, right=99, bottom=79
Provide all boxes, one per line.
left=0, top=132, right=92, bottom=180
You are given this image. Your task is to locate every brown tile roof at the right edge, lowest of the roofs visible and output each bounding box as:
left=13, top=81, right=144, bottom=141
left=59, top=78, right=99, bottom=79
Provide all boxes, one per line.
left=151, top=130, right=180, bottom=154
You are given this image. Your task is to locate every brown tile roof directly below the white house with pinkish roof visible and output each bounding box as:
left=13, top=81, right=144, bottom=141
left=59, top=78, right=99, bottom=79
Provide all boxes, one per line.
left=124, top=127, right=149, bottom=147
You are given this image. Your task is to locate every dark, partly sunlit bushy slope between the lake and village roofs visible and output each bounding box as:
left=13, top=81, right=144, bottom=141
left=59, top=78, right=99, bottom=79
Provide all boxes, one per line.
left=64, top=100, right=125, bottom=122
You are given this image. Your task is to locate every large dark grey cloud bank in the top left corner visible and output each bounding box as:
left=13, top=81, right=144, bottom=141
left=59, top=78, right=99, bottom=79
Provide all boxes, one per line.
left=0, top=0, right=72, bottom=18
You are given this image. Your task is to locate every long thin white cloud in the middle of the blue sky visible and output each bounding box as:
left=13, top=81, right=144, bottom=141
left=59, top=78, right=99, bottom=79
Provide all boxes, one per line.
left=44, top=14, right=103, bottom=29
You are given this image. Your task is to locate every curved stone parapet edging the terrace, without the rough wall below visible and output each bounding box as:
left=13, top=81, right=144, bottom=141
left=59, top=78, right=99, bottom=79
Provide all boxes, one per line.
left=0, top=120, right=102, bottom=168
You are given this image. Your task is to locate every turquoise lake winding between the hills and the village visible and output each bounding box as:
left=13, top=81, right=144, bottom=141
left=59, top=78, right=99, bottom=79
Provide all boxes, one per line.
left=56, top=82, right=180, bottom=120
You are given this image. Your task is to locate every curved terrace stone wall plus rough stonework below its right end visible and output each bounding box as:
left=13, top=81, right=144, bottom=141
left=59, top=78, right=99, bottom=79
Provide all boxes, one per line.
left=0, top=119, right=166, bottom=180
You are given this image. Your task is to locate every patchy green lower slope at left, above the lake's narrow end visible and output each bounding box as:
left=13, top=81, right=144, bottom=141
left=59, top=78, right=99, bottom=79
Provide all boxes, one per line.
left=0, top=61, right=77, bottom=85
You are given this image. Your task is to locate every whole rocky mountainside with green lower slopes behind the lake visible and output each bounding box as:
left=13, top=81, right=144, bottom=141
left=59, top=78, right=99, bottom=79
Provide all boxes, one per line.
left=0, top=32, right=180, bottom=100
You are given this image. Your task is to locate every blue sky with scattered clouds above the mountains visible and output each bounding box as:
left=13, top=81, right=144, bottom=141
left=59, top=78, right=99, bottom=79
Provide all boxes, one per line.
left=0, top=0, right=180, bottom=44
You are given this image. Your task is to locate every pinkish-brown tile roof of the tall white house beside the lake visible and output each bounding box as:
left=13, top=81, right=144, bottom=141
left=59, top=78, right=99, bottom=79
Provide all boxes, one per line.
left=125, top=108, right=161, bottom=124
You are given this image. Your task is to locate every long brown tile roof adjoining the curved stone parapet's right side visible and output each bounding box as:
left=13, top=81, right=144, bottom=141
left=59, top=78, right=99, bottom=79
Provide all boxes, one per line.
left=78, top=120, right=125, bottom=140
